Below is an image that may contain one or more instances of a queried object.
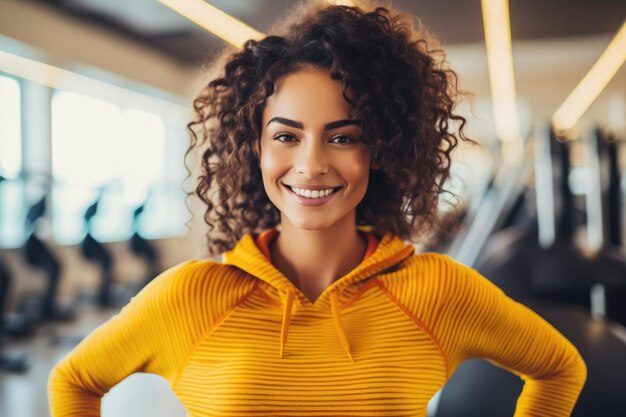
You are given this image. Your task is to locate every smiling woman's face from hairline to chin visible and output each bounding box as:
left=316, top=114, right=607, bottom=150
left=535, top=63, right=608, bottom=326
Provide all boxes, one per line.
left=255, top=69, right=371, bottom=230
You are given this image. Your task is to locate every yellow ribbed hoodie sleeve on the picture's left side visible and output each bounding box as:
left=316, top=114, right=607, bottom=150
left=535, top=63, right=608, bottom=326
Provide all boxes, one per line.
left=48, top=261, right=202, bottom=417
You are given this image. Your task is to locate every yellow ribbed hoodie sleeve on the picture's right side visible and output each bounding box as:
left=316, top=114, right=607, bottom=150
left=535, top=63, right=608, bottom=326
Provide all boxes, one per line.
left=435, top=256, right=587, bottom=417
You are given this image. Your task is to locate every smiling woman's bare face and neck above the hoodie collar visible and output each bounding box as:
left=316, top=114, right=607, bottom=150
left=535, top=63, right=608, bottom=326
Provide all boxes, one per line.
left=250, top=66, right=372, bottom=299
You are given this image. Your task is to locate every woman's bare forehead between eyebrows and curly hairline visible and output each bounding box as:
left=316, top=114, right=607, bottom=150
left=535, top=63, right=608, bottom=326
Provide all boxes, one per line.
left=263, top=69, right=350, bottom=127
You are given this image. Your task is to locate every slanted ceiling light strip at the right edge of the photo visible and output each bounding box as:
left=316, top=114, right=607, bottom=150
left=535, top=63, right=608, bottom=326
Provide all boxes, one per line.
left=552, top=21, right=626, bottom=132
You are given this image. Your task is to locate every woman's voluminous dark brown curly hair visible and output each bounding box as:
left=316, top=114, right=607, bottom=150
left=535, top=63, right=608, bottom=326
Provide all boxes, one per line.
left=185, top=1, right=476, bottom=255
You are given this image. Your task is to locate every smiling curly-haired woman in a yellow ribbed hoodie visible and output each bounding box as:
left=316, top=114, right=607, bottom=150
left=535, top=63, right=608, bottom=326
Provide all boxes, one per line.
left=49, top=2, right=586, bottom=417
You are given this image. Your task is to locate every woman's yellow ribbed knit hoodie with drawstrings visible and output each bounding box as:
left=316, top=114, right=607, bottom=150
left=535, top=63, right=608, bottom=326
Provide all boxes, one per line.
left=48, top=230, right=586, bottom=417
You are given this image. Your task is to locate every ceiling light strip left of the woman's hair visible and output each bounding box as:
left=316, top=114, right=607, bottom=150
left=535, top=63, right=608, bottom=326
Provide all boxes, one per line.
left=159, top=0, right=265, bottom=48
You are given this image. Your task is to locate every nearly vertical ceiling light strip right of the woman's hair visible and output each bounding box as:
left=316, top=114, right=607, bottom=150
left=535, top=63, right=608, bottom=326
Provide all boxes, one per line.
left=482, top=0, right=521, bottom=142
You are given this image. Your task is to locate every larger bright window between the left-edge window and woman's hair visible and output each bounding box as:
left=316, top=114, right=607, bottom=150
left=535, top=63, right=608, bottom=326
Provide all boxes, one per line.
left=52, top=92, right=187, bottom=244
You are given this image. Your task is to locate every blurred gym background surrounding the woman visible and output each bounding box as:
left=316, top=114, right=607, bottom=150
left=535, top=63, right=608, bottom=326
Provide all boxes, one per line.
left=0, top=0, right=626, bottom=417
